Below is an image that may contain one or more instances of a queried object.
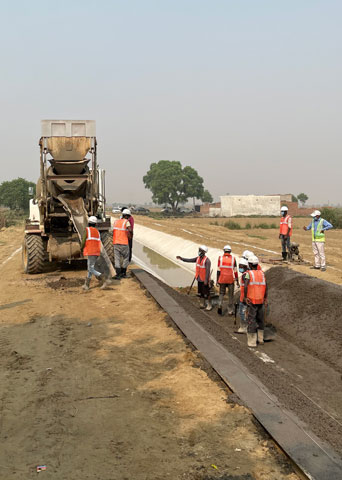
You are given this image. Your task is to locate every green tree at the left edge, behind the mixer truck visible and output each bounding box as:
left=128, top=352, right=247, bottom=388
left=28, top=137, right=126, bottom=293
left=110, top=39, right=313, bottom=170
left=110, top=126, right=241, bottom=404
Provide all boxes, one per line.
left=0, top=178, right=36, bottom=212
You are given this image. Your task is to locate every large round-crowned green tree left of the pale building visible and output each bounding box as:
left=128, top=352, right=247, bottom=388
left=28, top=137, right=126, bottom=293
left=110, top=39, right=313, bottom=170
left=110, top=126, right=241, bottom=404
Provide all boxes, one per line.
left=143, top=160, right=210, bottom=211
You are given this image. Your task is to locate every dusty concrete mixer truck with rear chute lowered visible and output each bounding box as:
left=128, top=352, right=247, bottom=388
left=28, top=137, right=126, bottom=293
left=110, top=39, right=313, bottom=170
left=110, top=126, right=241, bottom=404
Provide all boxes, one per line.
left=22, top=120, right=114, bottom=273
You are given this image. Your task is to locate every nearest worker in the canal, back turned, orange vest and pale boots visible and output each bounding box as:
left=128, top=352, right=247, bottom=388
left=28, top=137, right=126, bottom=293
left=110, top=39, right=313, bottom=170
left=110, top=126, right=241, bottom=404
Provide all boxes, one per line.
left=243, top=256, right=267, bottom=347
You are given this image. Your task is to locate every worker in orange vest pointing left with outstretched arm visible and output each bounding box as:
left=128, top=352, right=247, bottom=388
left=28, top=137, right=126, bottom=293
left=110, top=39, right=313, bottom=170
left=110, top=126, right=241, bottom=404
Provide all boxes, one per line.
left=176, top=245, right=213, bottom=311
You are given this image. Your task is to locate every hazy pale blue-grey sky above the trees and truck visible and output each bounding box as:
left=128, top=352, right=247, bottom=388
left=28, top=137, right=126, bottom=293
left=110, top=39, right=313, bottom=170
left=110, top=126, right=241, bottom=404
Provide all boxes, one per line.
left=0, top=0, right=342, bottom=205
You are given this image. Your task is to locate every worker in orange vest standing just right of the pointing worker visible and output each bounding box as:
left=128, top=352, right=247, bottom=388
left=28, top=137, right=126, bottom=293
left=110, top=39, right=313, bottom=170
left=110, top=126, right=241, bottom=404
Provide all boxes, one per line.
left=216, top=245, right=239, bottom=315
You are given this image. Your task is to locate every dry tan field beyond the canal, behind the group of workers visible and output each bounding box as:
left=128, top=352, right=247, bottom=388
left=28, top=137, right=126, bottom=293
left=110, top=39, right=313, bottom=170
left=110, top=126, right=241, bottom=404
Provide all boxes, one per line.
left=135, top=215, right=342, bottom=285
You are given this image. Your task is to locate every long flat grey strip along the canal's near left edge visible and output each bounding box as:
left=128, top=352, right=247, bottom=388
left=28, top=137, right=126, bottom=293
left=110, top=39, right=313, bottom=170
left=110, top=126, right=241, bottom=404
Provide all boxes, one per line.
left=132, top=269, right=342, bottom=480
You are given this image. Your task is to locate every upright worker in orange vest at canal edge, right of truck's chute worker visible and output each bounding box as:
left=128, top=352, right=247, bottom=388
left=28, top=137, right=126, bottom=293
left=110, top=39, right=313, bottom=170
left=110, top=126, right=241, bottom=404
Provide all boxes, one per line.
left=113, top=208, right=132, bottom=280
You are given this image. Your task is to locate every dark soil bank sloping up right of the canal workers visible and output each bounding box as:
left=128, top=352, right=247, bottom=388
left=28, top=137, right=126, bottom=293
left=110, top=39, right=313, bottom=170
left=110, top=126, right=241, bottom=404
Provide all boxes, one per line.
left=266, top=267, right=342, bottom=372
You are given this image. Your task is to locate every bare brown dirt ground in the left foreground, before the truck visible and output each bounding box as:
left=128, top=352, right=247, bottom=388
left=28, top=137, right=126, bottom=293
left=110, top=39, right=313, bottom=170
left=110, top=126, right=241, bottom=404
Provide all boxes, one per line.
left=0, top=228, right=299, bottom=480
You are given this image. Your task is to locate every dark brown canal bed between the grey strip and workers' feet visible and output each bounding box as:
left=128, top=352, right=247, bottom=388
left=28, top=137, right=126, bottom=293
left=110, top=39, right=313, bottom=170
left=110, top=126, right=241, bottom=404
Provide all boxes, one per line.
left=138, top=274, right=342, bottom=455
